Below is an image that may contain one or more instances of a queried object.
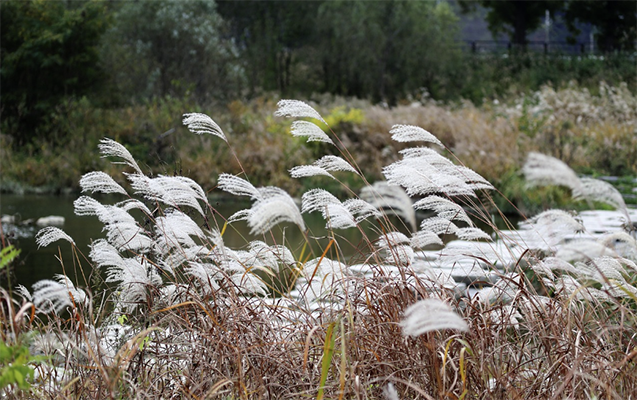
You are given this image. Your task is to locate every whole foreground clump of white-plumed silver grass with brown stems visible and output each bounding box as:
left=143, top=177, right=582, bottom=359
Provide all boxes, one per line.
left=0, top=97, right=637, bottom=399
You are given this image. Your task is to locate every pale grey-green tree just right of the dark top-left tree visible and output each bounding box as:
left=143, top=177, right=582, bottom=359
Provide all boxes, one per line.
left=102, top=0, right=242, bottom=101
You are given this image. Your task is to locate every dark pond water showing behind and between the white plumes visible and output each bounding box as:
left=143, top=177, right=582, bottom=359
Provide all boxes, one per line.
left=0, top=194, right=378, bottom=288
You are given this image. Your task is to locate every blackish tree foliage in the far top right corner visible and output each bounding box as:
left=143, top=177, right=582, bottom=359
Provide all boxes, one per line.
left=564, top=0, right=637, bottom=52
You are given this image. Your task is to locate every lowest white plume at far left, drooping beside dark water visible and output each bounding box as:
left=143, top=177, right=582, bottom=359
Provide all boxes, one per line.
left=33, top=274, right=88, bottom=313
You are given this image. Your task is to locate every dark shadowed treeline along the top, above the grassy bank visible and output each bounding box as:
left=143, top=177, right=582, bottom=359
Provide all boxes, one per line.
left=0, top=0, right=637, bottom=148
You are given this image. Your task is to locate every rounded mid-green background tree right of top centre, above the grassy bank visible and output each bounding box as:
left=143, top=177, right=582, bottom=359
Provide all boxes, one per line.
left=317, top=0, right=458, bottom=103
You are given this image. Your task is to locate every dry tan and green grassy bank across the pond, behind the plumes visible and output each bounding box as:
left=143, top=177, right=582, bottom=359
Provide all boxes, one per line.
left=0, top=83, right=637, bottom=216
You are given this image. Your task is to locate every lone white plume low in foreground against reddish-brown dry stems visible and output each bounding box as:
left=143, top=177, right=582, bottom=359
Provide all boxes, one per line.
left=400, top=298, right=469, bottom=336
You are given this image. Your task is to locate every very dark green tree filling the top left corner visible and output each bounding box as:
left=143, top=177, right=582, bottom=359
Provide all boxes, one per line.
left=0, top=0, right=107, bottom=146
